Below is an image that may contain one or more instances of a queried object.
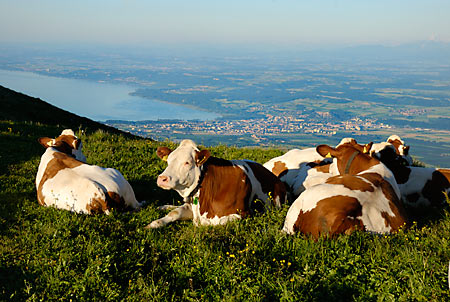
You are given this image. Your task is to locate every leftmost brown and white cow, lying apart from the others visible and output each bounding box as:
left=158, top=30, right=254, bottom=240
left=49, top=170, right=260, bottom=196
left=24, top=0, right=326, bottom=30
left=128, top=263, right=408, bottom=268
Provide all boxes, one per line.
left=36, top=129, right=140, bottom=214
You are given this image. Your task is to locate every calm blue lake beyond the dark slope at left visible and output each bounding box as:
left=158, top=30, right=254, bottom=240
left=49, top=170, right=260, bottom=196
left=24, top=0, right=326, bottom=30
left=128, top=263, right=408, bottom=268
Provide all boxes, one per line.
left=0, top=70, right=219, bottom=121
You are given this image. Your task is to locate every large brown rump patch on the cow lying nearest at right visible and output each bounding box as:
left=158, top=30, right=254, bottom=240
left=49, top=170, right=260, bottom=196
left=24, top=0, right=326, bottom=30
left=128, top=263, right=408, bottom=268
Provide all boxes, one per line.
left=294, top=195, right=364, bottom=238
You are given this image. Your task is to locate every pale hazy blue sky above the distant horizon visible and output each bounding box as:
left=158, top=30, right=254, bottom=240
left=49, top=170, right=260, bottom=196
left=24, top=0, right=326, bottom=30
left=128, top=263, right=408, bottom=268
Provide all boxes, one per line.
left=0, top=0, right=450, bottom=45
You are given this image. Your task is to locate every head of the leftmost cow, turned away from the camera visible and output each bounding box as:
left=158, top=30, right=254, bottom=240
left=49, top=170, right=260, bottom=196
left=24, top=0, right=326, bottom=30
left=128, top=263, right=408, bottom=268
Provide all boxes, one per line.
left=38, top=129, right=86, bottom=162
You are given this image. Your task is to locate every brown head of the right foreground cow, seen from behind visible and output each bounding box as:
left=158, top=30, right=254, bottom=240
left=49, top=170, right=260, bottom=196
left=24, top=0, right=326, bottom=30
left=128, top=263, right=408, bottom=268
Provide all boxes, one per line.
left=316, top=143, right=379, bottom=175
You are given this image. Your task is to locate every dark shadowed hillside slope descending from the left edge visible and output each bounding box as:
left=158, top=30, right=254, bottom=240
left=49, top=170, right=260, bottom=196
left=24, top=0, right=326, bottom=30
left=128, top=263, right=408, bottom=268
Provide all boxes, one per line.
left=0, top=86, right=143, bottom=174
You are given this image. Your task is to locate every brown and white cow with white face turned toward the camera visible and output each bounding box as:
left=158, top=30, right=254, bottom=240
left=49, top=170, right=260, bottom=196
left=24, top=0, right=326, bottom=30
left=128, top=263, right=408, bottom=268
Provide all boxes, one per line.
left=146, top=140, right=286, bottom=228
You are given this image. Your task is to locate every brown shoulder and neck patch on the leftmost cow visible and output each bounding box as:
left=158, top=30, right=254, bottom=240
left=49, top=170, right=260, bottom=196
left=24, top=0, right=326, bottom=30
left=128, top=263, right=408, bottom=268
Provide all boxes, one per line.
left=37, top=152, right=83, bottom=205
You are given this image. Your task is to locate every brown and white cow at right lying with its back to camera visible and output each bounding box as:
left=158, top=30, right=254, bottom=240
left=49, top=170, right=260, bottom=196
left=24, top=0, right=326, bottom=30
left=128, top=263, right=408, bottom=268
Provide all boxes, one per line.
left=283, top=144, right=407, bottom=238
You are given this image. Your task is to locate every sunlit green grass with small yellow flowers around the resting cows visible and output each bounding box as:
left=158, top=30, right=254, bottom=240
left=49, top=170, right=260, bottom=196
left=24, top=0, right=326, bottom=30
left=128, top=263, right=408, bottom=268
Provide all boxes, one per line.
left=0, top=122, right=450, bottom=301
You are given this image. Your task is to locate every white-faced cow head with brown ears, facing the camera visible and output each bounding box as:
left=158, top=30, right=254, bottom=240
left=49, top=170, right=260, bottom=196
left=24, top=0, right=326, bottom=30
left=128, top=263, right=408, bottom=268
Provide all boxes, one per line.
left=156, top=140, right=210, bottom=198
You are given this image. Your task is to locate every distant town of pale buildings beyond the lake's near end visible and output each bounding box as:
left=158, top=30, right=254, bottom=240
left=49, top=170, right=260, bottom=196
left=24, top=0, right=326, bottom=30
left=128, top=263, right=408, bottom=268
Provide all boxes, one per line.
left=106, top=112, right=391, bottom=141
